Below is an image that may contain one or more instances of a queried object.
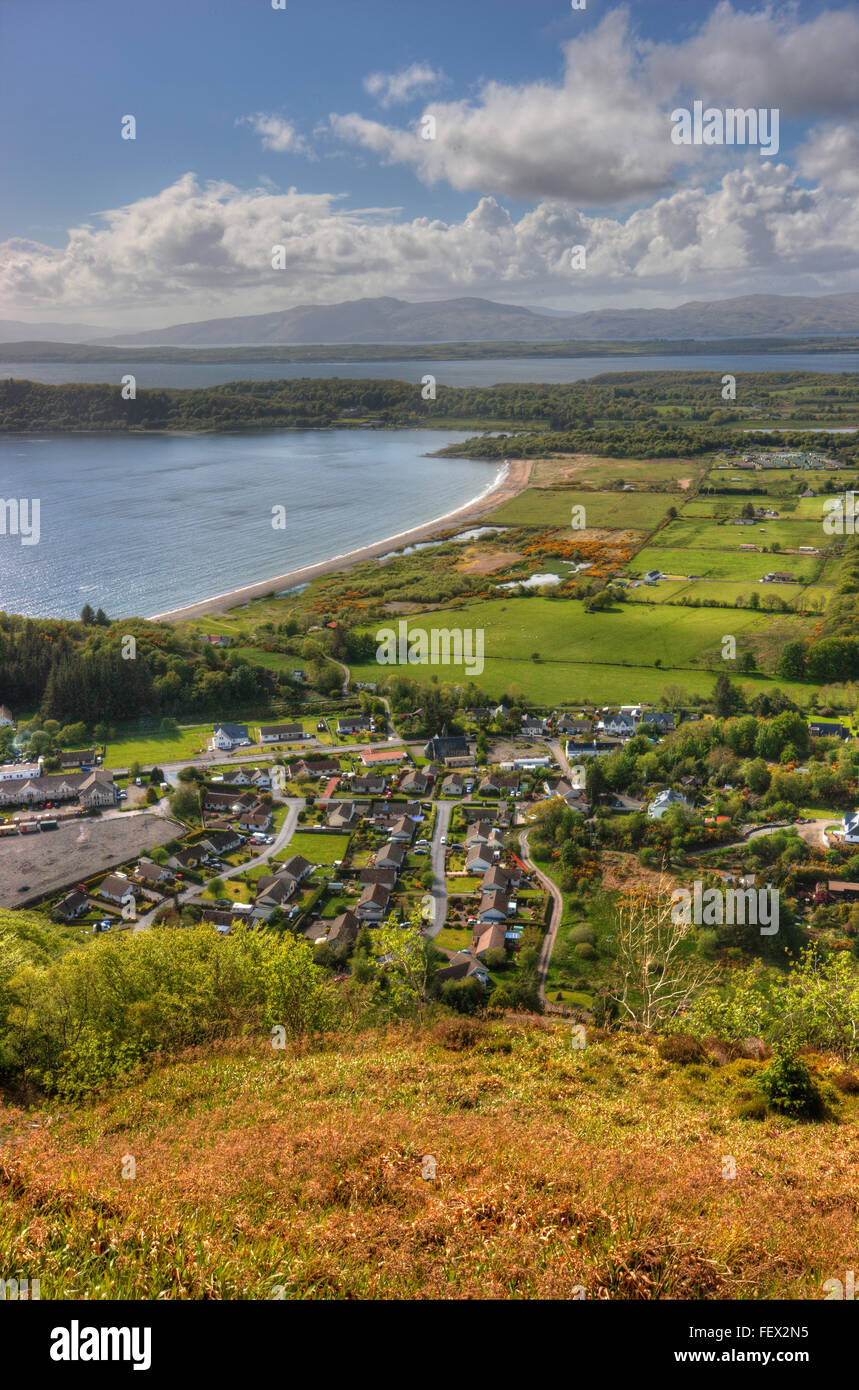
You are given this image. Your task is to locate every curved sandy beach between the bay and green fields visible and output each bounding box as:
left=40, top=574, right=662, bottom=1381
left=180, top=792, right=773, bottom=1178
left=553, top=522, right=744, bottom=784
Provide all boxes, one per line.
left=150, top=459, right=534, bottom=623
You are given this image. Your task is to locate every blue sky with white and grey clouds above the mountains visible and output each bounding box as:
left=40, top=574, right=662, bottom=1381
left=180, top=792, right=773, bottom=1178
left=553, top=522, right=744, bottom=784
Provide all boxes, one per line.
left=0, top=0, right=859, bottom=331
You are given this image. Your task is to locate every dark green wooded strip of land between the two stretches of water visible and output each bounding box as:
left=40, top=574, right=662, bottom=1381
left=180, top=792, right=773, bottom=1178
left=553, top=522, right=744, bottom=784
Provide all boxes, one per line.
left=0, top=364, right=859, bottom=457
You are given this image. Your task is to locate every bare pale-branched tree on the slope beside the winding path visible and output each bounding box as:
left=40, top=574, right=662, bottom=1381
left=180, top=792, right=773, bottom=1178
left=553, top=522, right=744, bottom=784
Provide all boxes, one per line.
left=612, top=880, right=716, bottom=1029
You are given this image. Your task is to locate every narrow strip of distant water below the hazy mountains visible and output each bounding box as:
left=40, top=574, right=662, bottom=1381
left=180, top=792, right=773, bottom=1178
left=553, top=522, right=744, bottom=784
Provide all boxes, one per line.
left=0, top=352, right=859, bottom=388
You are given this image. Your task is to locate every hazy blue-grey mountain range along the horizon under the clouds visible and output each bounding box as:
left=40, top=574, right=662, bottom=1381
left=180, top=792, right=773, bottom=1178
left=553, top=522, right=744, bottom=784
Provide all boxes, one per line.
left=6, top=293, right=859, bottom=348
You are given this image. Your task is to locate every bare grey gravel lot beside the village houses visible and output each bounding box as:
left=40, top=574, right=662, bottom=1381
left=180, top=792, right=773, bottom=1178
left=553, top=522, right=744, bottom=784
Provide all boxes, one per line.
left=0, top=813, right=183, bottom=908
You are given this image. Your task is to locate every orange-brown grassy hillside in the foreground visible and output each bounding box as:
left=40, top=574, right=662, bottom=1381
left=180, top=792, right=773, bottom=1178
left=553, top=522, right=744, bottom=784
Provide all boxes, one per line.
left=0, top=1019, right=859, bottom=1300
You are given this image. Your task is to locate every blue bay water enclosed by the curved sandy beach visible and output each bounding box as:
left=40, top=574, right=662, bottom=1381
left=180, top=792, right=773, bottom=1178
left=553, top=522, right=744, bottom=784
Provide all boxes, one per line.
left=0, top=430, right=483, bottom=617
